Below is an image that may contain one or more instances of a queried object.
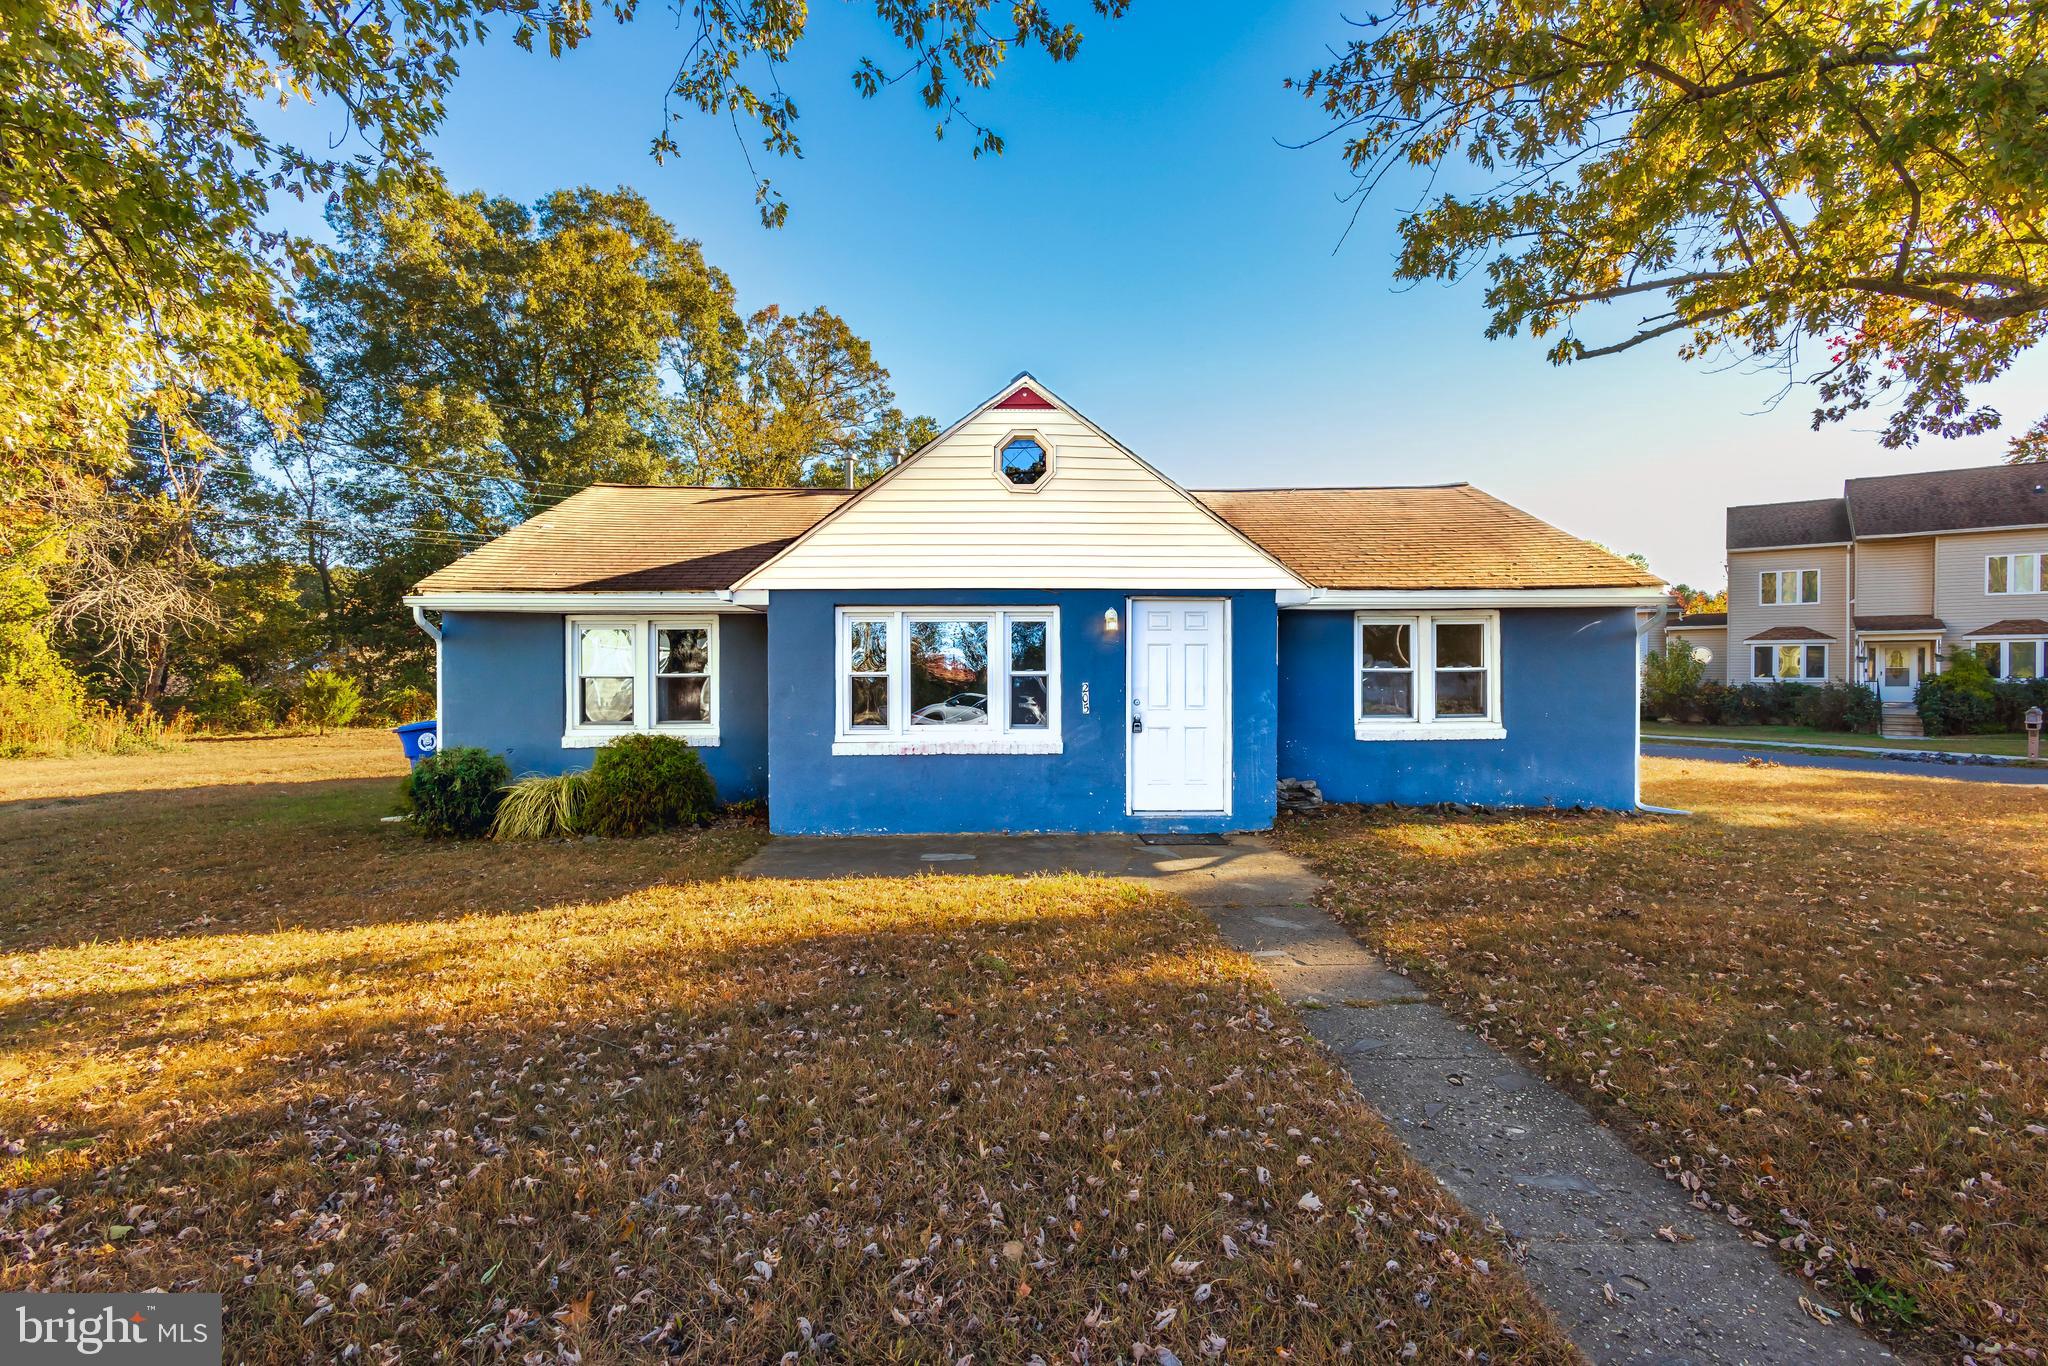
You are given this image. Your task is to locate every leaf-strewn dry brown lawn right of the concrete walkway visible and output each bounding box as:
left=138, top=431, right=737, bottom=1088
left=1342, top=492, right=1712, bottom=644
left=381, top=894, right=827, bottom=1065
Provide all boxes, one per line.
left=1286, top=760, right=2048, bottom=1360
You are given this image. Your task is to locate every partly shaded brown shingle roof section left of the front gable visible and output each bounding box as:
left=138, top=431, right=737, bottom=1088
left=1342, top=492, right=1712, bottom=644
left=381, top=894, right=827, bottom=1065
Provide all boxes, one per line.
left=418, top=483, right=848, bottom=592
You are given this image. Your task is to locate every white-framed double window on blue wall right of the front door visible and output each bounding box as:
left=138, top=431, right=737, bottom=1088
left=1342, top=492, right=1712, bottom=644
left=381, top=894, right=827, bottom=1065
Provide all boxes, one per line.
left=1352, top=612, right=1507, bottom=739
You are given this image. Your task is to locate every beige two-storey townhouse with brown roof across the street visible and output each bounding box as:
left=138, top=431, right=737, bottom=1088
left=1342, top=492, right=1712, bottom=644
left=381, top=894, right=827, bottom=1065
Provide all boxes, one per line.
left=1700, top=465, right=2048, bottom=707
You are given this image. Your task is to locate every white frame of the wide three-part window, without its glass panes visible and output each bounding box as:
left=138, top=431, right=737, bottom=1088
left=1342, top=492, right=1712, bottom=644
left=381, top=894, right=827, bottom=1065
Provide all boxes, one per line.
left=831, top=610, right=1065, bottom=756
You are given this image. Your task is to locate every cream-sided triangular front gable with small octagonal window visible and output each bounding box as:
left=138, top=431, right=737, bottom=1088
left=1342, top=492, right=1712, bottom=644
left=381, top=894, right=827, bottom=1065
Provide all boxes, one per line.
left=737, top=375, right=1305, bottom=590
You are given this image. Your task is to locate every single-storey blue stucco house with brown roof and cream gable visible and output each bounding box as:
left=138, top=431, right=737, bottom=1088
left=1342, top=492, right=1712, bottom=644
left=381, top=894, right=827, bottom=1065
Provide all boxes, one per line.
left=408, top=375, right=1663, bottom=834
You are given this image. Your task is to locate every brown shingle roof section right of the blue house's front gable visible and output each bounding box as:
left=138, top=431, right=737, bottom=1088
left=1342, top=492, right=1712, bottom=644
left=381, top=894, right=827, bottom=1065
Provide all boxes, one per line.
left=1194, top=483, right=1663, bottom=588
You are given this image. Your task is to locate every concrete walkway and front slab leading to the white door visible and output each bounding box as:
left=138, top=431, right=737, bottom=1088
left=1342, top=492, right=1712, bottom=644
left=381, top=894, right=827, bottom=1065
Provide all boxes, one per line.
left=741, top=836, right=1894, bottom=1362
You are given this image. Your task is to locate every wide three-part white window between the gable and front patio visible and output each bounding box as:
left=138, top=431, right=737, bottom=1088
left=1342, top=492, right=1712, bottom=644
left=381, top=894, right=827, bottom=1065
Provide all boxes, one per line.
left=834, top=606, right=1061, bottom=754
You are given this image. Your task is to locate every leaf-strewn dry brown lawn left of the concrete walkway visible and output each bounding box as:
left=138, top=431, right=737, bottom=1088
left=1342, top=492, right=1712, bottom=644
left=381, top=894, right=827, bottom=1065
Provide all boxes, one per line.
left=0, top=737, right=1573, bottom=1362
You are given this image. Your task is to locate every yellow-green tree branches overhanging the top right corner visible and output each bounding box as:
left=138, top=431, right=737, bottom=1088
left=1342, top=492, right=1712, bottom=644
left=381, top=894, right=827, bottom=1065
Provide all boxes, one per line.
left=1303, top=0, right=2048, bottom=453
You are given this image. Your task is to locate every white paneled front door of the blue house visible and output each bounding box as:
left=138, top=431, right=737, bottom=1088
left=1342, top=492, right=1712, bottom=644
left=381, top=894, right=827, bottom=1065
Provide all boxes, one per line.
left=1126, top=598, right=1231, bottom=811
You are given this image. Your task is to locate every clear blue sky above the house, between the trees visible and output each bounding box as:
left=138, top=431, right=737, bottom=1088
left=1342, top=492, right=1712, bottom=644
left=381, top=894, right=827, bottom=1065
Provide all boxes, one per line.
left=268, top=0, right=2048, bottom=586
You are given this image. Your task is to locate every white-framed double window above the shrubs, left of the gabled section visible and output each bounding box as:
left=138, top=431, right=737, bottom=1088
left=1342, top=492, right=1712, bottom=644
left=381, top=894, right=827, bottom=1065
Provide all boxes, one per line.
left=561, top=616, right=719, bottom=750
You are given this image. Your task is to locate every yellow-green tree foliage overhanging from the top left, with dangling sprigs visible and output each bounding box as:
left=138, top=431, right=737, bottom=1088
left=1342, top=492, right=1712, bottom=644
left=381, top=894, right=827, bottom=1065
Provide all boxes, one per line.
left=0, top=0, right=1128, bottom=475
